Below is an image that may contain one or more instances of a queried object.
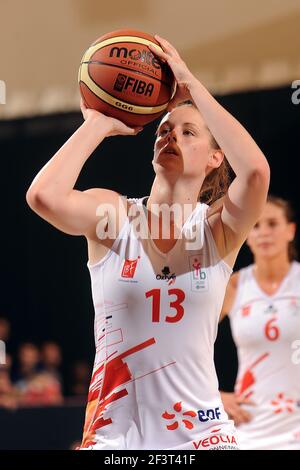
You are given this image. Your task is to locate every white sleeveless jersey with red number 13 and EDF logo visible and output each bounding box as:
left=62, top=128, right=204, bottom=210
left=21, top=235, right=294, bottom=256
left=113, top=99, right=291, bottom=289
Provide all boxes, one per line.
left=81, top=198, right=236, bottom=450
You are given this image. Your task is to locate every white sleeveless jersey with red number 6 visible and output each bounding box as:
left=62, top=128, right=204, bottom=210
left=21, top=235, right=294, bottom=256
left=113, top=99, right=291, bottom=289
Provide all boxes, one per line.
left=229, top=261, right=300, bottom=450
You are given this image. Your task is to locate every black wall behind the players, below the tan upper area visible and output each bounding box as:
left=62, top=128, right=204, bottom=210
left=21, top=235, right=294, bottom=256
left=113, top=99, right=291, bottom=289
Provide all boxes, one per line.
left=0, top=87, right=300, bottom=389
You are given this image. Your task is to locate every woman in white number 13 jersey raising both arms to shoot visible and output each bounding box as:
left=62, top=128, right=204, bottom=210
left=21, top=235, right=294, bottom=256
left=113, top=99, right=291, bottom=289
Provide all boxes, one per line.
left=27, top=38, right=269, bottom=450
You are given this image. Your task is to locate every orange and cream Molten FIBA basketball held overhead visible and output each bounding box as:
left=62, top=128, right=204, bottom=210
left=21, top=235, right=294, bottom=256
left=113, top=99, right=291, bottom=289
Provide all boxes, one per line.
left=78, top=29, right=175, bottom=127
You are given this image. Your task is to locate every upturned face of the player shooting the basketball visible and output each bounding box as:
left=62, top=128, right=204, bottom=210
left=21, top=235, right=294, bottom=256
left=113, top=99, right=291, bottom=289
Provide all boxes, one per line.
left=152, top=106, right=223, bottom=177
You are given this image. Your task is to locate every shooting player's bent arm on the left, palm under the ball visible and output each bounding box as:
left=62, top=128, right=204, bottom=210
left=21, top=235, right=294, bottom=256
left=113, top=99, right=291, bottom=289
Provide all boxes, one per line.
left=26, top=102, right=140, bottom=239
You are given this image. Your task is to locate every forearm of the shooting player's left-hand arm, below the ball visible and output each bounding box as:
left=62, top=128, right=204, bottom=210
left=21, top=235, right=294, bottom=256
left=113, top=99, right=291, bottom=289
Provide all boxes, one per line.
left=27, top=119, right=108, bottom=199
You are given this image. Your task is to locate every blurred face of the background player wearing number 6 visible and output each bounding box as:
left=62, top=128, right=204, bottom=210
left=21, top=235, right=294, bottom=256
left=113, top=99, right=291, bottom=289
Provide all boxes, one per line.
left=247, top=202, right=295, bottom=259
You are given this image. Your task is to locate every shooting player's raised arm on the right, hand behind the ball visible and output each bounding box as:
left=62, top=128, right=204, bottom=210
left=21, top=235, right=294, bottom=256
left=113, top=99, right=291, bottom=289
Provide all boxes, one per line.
left=149, top=36, right=270, bottom=265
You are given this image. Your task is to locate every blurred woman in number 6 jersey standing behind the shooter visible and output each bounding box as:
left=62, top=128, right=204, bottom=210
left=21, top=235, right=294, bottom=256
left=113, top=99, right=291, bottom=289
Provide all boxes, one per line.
left=221, top=197, right=300, bottom=449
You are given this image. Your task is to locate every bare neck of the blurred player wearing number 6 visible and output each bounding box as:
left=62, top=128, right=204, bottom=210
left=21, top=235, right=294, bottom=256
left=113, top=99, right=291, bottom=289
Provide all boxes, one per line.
left=254, top=252, right=291, bottom=282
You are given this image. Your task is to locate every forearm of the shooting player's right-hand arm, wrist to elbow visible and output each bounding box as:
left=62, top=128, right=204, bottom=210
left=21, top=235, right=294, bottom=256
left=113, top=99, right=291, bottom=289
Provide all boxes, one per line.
left=188, top=78, right=268, bottom=177
